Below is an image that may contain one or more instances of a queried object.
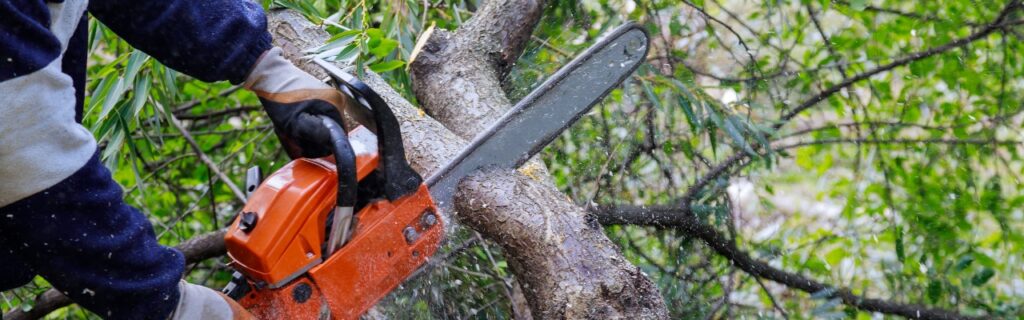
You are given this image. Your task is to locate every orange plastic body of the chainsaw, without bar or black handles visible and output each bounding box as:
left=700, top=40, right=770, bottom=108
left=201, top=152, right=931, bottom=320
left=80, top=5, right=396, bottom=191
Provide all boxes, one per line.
left=225, top=127, right=443, bottom=319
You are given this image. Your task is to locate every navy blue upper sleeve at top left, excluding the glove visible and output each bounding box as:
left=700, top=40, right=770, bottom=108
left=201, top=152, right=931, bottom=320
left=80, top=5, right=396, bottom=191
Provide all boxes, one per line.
left=89, top=0, right=271, bottom=83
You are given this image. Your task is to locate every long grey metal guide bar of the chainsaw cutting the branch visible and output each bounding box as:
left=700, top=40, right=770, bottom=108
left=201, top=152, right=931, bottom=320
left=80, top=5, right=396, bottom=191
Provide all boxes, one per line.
left=427, top=23, right=648, bottom=211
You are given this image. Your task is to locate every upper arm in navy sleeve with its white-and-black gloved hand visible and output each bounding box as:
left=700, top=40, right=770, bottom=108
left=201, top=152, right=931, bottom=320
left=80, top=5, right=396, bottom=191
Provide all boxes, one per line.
left=89, top=0, right=368, bottom=158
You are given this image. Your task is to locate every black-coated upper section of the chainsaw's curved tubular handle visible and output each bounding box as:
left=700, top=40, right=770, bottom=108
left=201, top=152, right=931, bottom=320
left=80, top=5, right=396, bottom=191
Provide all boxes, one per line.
left=319, top=116, right=357, bottom=207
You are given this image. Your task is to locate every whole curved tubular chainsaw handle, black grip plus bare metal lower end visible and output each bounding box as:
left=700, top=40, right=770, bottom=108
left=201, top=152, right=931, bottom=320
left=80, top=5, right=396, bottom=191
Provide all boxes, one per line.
left=319, top=116, right=357, bottom=256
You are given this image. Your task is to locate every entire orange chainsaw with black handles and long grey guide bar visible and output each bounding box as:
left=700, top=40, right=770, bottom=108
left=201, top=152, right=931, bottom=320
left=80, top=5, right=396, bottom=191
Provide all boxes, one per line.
left=223, top=24, right=648, bottom=319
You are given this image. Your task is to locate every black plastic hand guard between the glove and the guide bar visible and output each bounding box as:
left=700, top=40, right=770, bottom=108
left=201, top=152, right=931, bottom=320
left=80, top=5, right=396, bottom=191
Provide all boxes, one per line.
left=322, top=69, right=423, bottom=201
